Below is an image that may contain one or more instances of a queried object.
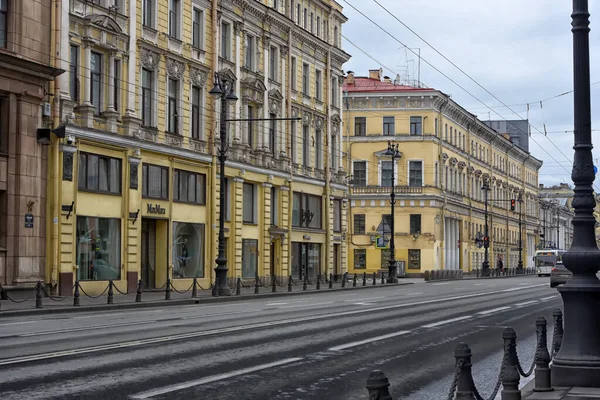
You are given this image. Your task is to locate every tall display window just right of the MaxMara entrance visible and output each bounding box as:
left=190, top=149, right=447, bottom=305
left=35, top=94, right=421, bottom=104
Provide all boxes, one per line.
left=173, top=222, right=204, bottom=278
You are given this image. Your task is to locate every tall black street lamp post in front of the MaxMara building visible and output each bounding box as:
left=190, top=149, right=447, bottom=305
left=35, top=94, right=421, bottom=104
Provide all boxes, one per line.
left=210, top=72, right=238, bottom=296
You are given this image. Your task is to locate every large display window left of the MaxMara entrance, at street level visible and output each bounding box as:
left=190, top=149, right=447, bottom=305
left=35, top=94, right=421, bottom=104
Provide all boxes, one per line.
left=77, top=217, right=121, bottom=281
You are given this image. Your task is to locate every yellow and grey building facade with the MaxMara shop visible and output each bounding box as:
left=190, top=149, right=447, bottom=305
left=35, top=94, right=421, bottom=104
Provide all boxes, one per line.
left=46, top=0, right=349, bottom=294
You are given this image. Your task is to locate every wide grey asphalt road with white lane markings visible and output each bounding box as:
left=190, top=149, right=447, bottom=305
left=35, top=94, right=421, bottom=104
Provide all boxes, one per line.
left=0, top=277, right=561, bottom=400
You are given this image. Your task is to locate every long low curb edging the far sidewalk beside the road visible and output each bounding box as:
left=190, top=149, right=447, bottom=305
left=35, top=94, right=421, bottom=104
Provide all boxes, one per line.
left=0, top=282, right=414, bottom=319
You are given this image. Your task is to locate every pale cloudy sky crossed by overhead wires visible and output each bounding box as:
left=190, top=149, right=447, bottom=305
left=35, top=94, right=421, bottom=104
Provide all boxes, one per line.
left=338, top=0, right=600, bottom=191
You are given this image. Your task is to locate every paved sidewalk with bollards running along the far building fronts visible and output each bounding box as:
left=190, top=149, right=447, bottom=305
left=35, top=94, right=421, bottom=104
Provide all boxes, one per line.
left=0, top=278, right=423, bottom=318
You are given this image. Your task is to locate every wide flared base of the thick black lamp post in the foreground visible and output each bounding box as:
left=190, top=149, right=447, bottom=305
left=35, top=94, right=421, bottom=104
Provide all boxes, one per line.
left=552, top=282, right=600, bottom=387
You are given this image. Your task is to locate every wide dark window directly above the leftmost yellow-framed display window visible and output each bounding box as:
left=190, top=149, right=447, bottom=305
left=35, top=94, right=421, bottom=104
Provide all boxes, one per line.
left=78, top=153, right=121, bottom=194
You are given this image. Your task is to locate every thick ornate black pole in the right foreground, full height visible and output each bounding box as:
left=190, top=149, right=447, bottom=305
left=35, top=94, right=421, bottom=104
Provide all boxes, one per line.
left=551, top=0, right=600, bottom=387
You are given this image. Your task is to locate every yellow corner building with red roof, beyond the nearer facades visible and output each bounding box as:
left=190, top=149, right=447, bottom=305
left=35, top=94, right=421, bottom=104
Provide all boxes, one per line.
left=343, top=70, right=542, bottom=275
